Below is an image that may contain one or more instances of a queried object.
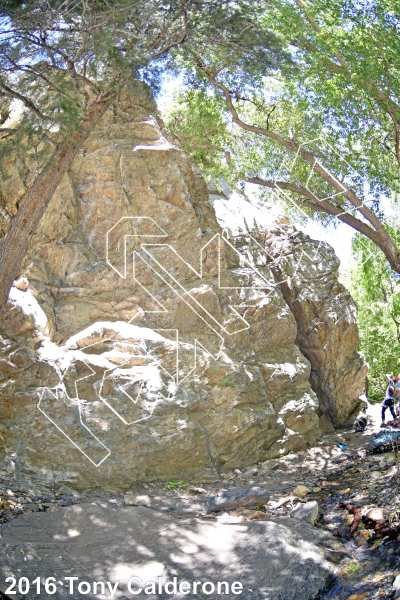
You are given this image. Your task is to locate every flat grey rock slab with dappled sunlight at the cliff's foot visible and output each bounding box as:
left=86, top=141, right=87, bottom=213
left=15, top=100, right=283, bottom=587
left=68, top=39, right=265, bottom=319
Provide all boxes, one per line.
left=0, top=503, right=343, bottom=600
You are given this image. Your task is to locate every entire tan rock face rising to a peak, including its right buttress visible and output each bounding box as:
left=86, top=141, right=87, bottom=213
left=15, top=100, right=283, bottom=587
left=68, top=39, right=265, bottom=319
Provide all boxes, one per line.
left=0, top=82, right=366, bottom=489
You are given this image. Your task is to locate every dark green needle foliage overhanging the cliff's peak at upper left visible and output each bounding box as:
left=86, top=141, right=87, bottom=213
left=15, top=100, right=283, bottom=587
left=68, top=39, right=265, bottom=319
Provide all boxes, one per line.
left=0, top=0, right=288, bottom=182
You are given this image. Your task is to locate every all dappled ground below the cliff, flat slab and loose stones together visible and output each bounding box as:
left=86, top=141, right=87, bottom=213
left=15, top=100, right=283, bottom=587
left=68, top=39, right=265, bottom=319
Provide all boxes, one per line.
left=0, top=400, right=400, bottom=600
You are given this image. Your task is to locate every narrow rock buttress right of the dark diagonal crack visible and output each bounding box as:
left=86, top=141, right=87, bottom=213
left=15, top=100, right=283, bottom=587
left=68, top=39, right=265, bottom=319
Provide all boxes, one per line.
left=222, top=219, right=367, bottom=426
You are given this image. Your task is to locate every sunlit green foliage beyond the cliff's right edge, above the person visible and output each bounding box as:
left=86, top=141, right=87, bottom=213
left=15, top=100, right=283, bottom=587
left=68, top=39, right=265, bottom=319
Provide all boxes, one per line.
left=346, top=232, right=400, bottom=401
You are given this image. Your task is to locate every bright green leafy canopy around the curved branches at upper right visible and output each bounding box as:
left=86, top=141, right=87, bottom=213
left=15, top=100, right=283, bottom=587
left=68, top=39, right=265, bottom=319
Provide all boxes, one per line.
left=167, top=0, right=400, bottom=232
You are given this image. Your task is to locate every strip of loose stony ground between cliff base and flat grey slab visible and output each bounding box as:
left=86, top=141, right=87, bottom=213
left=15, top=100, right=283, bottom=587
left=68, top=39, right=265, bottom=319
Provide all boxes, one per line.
left=0, top=407, right=400, bottom=600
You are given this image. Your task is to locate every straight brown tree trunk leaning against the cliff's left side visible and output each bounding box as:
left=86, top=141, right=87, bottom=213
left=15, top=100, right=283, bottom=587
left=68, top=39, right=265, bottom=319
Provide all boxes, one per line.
left=0, top=97, right=111, bottom=309
